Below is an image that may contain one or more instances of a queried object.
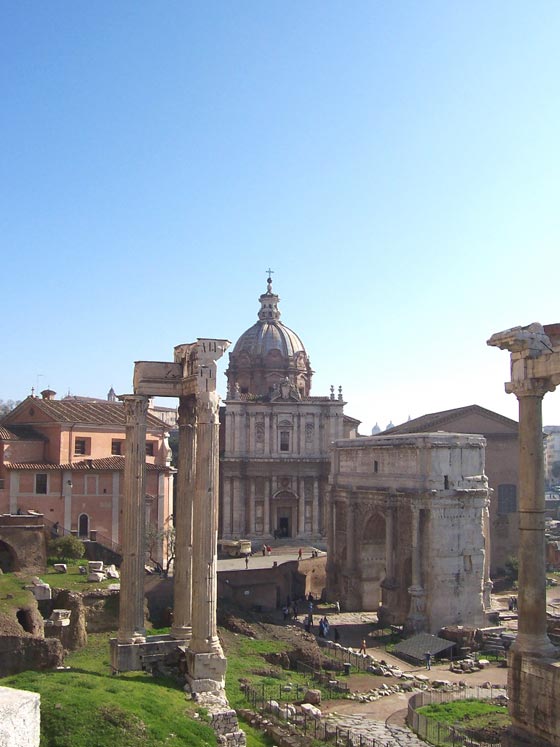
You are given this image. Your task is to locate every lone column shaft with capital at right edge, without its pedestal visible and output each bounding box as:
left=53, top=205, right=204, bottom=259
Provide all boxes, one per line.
left=512, top=379, right=557, bottom=656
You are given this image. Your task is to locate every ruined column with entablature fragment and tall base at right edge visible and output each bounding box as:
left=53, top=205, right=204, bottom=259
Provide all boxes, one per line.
left=488, top=323, right=560, bottom=747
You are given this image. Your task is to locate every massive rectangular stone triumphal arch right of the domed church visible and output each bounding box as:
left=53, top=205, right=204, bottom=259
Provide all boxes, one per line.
left=327, top=432, right=492, bottom=633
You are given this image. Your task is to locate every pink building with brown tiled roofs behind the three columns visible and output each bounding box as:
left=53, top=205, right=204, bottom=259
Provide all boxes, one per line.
left=0, top=389, right=173, bottom=560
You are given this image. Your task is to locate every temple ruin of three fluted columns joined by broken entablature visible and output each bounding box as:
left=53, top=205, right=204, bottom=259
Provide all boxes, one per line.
left=111, top=338, right=229, bottom=693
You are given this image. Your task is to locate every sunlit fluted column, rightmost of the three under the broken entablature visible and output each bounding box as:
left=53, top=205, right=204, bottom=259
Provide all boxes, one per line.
left=189, top=392, right=221, bottom=654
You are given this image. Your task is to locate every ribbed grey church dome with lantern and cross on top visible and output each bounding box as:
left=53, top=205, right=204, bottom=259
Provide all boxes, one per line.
left=226, top=277, right=313, bottom=399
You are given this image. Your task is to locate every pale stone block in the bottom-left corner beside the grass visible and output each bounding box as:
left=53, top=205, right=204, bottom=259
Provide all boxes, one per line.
left=0, top=687, right=41, bottom=747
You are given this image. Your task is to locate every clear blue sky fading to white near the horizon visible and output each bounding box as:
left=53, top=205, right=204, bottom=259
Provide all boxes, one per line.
left=0, top=0, right=560, bottom=433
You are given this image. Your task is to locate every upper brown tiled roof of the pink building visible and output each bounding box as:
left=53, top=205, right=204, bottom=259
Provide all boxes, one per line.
left=7, top=397, right=167, bottom=429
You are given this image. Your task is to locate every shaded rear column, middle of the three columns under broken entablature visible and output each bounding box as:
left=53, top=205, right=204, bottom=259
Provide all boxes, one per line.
left=171, top=396, right=197, bottom=641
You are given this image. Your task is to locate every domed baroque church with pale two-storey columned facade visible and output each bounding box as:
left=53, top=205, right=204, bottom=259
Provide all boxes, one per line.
left=220, top=278, right=359, bottom=542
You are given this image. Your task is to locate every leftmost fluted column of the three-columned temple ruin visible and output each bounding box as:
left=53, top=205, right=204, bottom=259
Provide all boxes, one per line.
left=117, top=394, right=148, bottom=643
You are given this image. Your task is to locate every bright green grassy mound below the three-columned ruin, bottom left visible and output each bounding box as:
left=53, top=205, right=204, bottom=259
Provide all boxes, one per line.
left=0, top=634, right=216, bottom=747
